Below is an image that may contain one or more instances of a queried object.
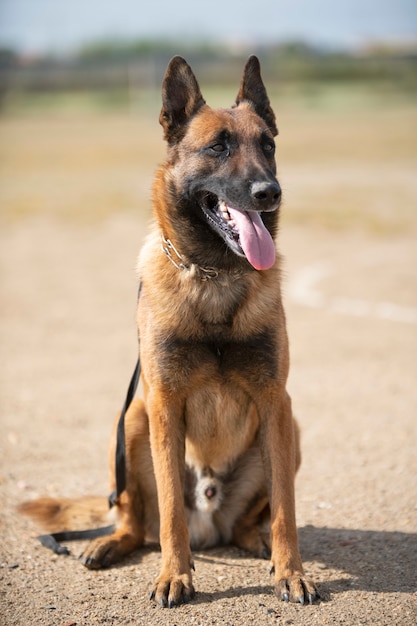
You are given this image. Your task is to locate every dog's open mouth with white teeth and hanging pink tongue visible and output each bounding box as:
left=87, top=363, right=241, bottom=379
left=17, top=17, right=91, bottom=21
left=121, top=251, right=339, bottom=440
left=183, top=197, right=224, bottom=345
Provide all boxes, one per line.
left=201, top=192, right=275, bottom=270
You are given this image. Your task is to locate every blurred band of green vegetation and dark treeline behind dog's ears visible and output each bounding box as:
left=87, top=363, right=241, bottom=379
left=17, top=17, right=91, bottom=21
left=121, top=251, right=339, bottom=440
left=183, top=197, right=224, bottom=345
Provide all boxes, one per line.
left=0, top=40, right=417, bottom=115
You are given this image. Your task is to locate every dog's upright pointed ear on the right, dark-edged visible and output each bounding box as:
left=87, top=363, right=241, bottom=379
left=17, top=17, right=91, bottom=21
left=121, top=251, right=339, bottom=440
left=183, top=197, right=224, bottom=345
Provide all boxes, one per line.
left=235, top=56, right=278, bottom=135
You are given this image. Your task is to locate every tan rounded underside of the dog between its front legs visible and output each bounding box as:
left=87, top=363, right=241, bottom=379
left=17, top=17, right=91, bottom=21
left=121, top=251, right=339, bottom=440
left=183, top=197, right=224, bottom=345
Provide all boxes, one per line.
left=185, top=383, right=259, bottom=472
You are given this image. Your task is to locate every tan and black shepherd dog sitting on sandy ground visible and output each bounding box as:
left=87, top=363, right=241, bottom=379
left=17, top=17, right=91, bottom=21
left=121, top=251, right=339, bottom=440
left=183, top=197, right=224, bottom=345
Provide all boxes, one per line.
left=18, top=56, right=320, bottom=607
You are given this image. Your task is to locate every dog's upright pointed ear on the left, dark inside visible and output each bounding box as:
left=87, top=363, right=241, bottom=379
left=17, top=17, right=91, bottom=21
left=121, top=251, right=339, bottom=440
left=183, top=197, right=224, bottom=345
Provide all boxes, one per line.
left=159, top=56, right=205, bottom=144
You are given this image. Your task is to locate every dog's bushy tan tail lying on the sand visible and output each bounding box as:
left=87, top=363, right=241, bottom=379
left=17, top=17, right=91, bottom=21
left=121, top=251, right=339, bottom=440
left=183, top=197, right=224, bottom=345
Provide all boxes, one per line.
left=17, top=496, right=111, bottom=532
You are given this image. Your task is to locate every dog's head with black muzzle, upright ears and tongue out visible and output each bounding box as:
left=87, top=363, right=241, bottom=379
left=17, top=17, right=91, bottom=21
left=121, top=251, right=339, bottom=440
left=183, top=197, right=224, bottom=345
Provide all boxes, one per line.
left=156, top=56, right=281, bottom=270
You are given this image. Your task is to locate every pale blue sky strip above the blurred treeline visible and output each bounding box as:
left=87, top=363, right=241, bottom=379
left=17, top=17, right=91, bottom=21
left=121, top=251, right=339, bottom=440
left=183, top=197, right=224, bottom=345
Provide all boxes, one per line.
left=0, top=0, right=417, bottom=56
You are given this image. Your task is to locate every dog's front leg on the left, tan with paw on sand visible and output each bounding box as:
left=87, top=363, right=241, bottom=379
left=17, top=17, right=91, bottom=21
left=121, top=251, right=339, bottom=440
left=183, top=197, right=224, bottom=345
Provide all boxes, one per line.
left=147, top=394, right=194, bottom=608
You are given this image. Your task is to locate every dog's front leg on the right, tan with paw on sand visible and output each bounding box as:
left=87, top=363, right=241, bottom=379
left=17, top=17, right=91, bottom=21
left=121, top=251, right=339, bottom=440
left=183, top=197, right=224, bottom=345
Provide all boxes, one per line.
left=262, top=389, right=319, bottom=604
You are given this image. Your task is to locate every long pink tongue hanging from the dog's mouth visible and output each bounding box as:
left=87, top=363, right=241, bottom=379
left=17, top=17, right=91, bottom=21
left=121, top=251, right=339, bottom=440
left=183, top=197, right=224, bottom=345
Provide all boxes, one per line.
left=227, top=206, right=275, bottom=270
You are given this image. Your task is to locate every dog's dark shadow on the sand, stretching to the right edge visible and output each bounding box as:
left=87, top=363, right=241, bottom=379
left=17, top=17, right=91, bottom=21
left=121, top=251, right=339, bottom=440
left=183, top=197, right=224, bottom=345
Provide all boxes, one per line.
left=83, top=526, right=417, bottom=603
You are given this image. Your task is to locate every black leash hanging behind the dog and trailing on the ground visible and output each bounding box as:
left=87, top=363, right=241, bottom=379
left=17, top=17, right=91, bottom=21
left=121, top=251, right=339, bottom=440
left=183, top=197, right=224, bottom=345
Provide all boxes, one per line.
left=38, top=282, right=142, bottom=554
